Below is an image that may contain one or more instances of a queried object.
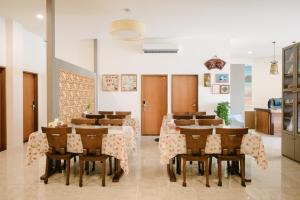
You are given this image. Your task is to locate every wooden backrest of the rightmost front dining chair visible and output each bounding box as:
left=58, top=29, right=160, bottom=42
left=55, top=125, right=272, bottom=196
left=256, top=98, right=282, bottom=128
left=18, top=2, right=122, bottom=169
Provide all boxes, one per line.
left=216, top=128, right=248, bottom=155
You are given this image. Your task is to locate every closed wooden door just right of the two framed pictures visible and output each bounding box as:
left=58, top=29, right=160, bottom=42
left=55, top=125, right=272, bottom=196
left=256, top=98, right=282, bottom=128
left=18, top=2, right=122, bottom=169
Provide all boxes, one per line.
left=141, top=75, right=168, bottom=135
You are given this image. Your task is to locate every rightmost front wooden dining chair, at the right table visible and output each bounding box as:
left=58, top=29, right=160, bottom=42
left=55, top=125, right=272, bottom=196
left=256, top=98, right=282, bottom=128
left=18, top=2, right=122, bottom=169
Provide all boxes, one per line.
left=215, top=128, right=248, bottom=187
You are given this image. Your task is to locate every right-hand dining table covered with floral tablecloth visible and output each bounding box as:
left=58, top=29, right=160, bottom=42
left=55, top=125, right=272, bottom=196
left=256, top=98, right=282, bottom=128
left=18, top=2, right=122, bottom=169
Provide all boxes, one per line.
left=159, top=116, right=268, bottom=182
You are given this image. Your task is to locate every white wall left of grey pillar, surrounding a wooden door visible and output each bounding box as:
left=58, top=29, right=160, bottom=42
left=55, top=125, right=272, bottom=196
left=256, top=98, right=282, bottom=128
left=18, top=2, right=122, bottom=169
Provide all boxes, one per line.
left=0, top=20, right=47, bottom=149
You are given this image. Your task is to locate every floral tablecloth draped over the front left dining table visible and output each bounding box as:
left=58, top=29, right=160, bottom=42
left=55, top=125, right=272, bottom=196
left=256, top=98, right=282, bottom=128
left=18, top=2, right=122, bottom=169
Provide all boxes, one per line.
left=26, top=126, right=136, bottom=174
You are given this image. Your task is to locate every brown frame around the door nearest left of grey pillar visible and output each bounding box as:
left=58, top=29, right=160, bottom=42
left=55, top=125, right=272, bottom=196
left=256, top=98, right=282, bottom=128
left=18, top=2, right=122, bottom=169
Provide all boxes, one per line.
left=23, top=71, right=39, bottom=142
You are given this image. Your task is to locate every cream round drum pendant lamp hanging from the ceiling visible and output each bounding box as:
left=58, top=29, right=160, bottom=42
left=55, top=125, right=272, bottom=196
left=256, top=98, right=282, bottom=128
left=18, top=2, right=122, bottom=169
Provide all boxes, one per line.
left=109, top=8, right=146, bottom=41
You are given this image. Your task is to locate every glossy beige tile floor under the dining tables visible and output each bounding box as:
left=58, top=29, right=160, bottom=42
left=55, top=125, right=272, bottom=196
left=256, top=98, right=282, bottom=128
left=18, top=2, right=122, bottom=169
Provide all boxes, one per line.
left=0, top=133, right=300, bottom=200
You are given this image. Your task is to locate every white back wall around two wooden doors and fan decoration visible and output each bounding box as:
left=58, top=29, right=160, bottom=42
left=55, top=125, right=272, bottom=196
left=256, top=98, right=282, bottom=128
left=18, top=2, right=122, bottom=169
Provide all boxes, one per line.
left=98, top=38, right=230, bottom=118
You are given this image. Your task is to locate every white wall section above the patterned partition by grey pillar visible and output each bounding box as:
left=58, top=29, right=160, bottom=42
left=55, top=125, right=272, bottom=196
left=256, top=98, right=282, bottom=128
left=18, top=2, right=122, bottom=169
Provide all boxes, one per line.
left=55, top=39, right=94, bottom=72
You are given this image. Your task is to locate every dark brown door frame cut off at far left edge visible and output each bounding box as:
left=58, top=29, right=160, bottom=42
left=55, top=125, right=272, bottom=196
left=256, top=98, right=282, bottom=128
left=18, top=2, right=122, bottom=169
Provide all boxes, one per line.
left=0, top=66, right=7, bottom=151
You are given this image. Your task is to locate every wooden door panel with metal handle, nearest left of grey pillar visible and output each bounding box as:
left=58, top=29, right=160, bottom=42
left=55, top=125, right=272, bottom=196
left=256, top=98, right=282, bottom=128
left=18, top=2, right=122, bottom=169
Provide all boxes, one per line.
left=23, top=72, right=38, bottom=142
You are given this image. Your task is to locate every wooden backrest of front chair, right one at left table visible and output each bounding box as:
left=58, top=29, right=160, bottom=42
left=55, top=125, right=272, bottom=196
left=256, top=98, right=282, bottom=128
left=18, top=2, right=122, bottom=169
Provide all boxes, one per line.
left=75, top=128, right=108, bottom=156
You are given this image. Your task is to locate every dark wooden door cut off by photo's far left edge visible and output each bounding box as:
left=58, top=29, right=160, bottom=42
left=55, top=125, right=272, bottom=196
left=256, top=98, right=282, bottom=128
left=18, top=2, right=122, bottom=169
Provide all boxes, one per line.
left=0, top=68, right=6, bottom=151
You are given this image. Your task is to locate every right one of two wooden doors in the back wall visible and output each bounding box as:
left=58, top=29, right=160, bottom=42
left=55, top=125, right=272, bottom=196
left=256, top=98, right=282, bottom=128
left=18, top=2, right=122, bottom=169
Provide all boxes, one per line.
left=172, top=75, right=198, bottom=113
